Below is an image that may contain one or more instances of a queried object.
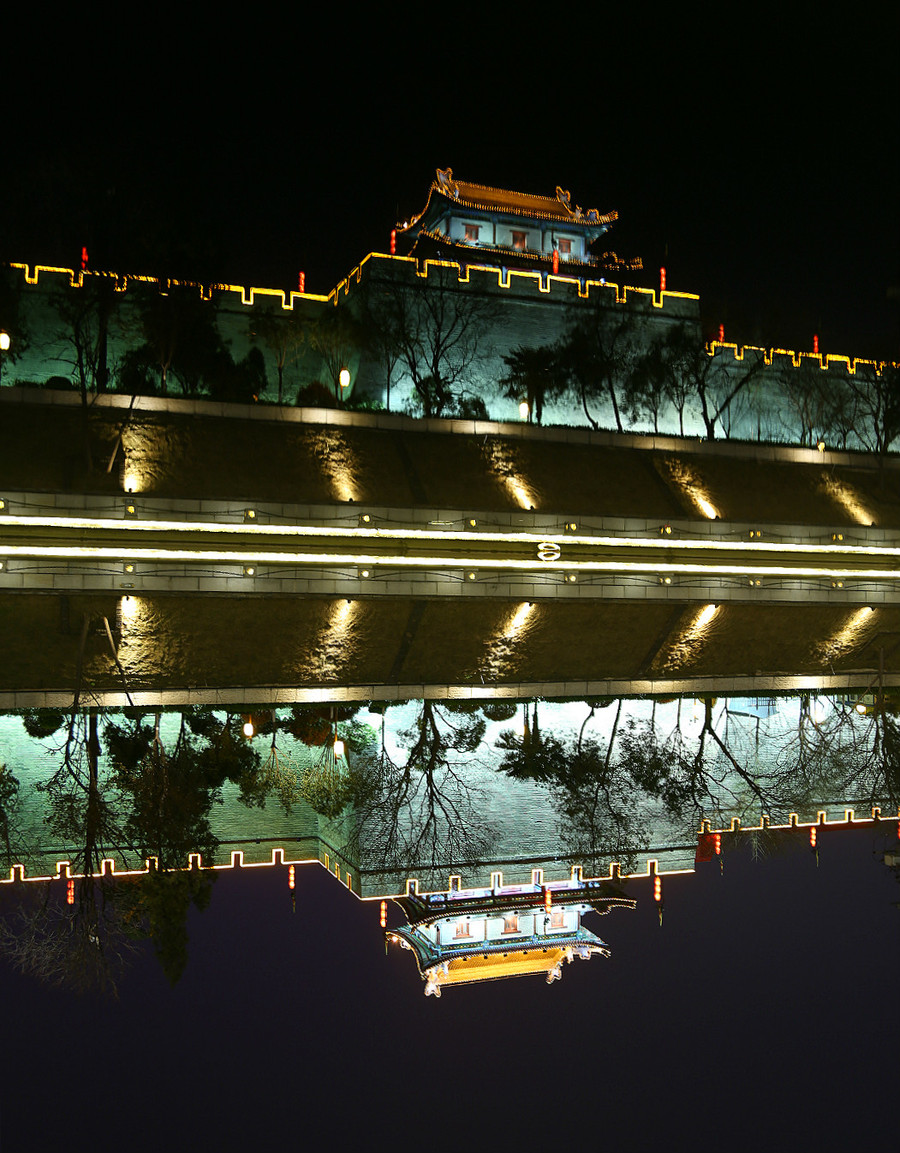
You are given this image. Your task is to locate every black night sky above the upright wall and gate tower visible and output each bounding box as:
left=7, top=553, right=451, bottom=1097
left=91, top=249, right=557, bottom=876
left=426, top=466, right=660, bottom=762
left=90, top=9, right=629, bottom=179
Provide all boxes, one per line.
left=0, top=12, right=900, bottom=356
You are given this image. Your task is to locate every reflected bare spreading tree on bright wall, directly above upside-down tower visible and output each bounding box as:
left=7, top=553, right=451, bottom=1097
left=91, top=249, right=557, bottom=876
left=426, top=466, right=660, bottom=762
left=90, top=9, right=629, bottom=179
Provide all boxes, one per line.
left=351, top=701, right=491, bottom=871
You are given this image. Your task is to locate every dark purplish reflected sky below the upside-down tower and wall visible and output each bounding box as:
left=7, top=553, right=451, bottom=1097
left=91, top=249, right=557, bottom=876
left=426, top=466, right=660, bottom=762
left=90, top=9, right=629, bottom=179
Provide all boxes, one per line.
left=0, top=826, right=900, bottom=1153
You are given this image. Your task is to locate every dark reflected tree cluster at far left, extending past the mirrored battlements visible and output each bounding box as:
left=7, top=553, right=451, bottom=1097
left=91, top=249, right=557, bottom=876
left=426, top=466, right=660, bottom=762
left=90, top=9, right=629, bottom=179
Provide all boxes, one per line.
left=0, top=707, right=265, bottom=992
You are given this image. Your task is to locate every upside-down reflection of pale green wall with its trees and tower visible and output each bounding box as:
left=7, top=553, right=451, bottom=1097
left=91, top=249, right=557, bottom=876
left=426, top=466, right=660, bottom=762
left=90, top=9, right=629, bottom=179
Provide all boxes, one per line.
left=0, top=687, right=900, bottom=992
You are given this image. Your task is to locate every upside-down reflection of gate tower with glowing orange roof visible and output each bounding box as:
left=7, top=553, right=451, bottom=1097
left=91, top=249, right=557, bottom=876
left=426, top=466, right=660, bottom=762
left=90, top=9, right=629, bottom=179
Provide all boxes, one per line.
left=386, top=868, right=636, bottom=997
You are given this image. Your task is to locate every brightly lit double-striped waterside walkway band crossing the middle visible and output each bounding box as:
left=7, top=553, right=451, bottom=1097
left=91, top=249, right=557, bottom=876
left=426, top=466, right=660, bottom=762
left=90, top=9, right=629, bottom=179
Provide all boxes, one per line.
left=0, top=493, right=900, bottom=604
